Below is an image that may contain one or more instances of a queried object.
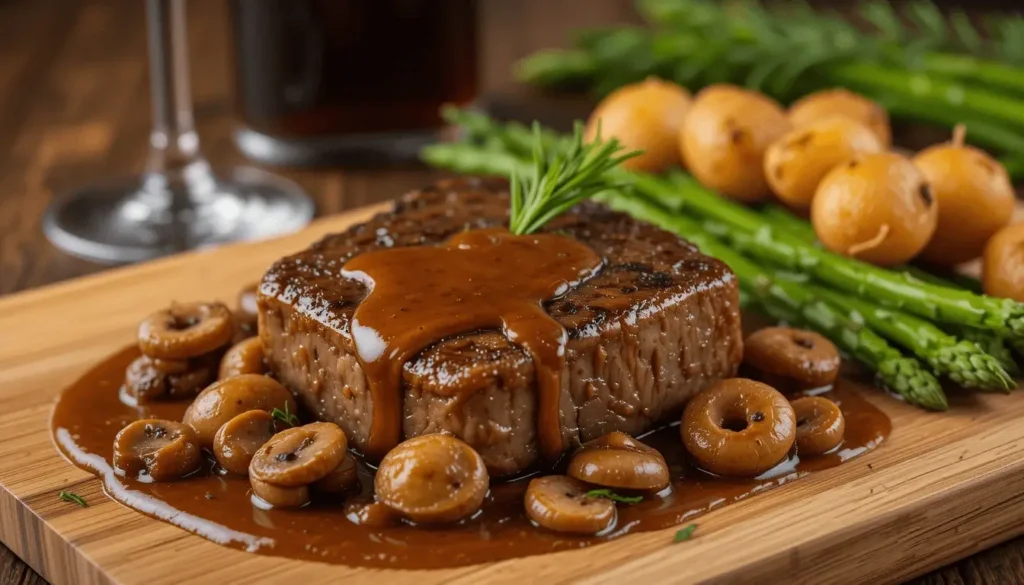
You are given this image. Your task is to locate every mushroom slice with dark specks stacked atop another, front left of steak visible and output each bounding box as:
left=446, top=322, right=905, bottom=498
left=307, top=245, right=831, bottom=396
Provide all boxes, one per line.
left=249, top=422, right=348, bottom=488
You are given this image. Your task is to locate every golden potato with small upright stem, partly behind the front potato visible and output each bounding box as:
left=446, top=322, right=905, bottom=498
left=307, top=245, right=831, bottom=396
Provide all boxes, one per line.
left=913, top=141, right=1016, bottom=266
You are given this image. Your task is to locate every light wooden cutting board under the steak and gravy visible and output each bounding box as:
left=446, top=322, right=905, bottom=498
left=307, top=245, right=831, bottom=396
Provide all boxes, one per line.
left=0, top=202, right=1024, bottom=585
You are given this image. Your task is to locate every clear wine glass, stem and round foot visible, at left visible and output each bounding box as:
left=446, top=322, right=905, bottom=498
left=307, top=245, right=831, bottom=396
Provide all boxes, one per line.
left=43, top=0, right=313, bottom=263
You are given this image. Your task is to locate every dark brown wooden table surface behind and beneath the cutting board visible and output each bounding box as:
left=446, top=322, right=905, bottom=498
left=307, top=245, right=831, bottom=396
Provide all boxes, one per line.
left=0, top=0, right=1024, bottom=585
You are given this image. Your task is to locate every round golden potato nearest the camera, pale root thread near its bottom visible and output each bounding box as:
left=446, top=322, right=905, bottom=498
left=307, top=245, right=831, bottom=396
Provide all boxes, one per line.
left=811, top=153, right=938, bottom=266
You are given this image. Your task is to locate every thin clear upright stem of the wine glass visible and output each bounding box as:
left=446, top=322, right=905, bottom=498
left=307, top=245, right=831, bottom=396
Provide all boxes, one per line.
left=146, top=0, right=205, bottom=180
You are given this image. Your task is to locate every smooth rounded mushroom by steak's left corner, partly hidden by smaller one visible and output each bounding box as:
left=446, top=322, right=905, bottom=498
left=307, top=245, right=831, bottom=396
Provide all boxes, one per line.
left=182, top=374, right=296, bottom=449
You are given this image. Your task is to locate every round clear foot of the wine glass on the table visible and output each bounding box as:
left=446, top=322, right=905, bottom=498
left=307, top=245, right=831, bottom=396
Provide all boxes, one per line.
left=43, top=167, right=313, bottom=263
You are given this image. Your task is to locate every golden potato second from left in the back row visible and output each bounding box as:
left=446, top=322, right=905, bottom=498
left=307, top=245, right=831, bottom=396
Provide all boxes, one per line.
left=679, top=85, right=790, bottom=202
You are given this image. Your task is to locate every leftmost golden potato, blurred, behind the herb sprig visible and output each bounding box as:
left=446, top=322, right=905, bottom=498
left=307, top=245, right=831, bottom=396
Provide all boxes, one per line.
left=585, top=77, right=690, bottom=173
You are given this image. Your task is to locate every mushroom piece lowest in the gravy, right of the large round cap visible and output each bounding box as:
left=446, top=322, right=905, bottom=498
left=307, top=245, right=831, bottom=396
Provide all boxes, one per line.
left=524, top=475, right=617, bottom=535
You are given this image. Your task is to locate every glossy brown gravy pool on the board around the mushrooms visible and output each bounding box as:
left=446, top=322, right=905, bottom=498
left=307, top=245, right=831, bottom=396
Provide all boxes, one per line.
left=51, top=347, right=890, bottom=569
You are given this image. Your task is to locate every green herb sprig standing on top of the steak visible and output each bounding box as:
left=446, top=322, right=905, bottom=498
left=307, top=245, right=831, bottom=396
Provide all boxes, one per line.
left=509, top=122, right=640, bottom=236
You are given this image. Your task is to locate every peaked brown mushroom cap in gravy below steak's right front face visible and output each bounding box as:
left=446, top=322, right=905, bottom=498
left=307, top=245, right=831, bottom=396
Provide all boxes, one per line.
left=567, top=431, right=669, bottom=490
